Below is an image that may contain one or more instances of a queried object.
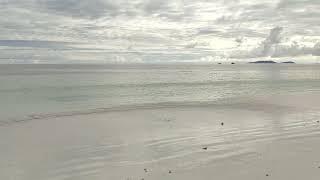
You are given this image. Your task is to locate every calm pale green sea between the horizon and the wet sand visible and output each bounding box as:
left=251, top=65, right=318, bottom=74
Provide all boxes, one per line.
left=0, top=64, right=320, bottom=122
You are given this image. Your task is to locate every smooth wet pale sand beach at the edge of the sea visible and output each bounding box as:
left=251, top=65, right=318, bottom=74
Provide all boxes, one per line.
left=0, top=92, right=320, bottom=180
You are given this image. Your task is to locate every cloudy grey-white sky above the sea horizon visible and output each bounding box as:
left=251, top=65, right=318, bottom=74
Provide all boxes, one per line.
left=0, top=0, right=320, bottom=63
